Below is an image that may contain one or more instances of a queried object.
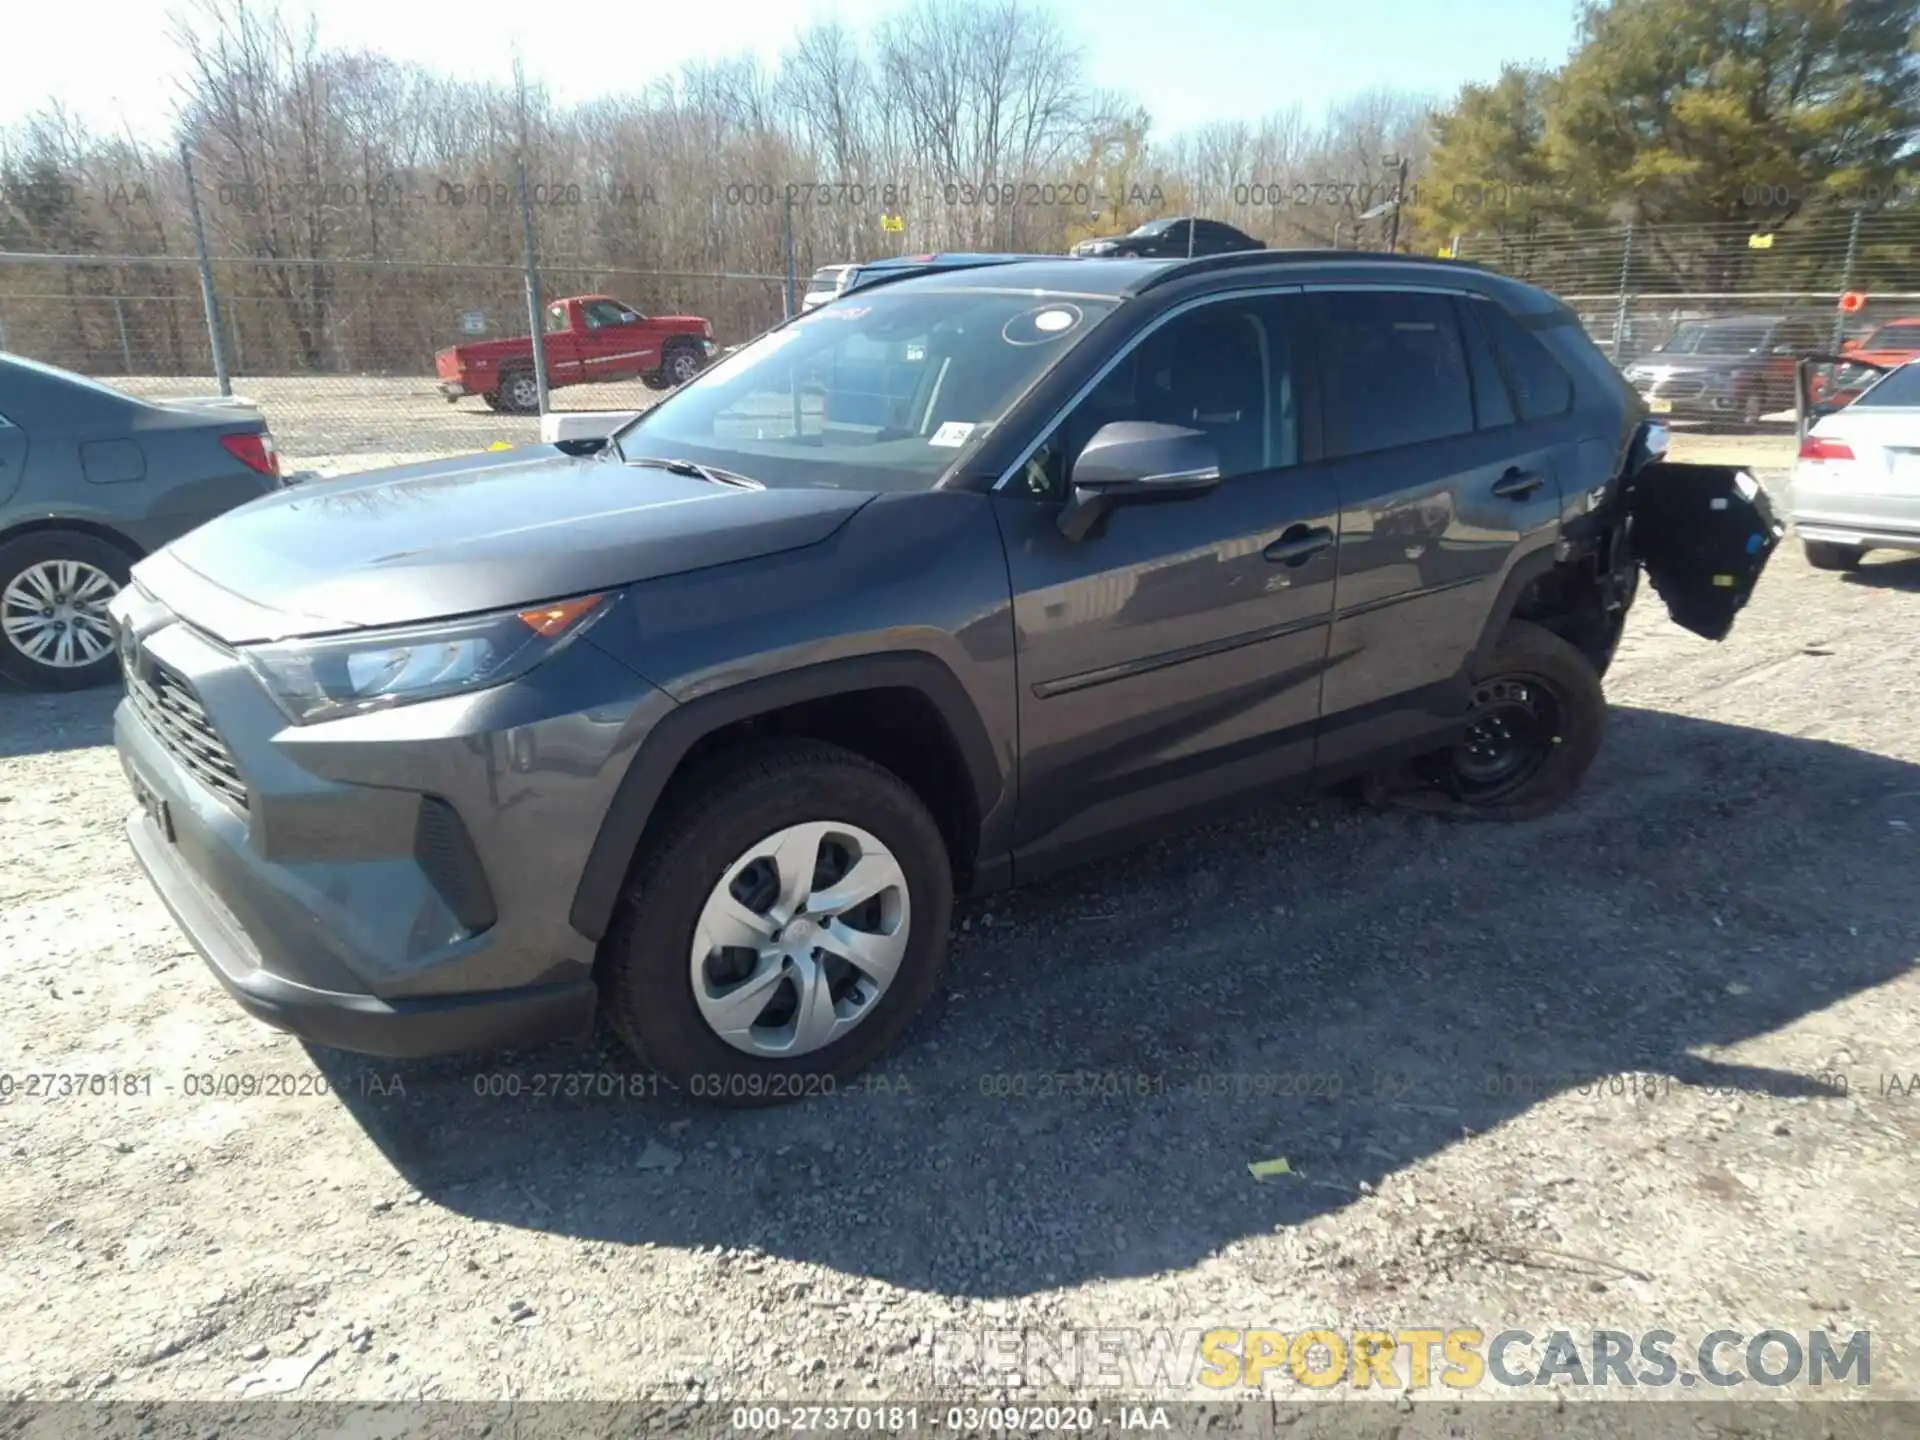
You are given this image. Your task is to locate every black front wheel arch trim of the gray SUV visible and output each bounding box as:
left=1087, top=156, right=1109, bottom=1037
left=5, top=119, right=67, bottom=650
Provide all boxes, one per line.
left=568, top=651, right=1006, bottom=941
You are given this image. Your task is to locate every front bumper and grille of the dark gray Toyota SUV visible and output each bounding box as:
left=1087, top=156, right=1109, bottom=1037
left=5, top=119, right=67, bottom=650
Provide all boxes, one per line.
left=113, top=588, right=670, bottom=1056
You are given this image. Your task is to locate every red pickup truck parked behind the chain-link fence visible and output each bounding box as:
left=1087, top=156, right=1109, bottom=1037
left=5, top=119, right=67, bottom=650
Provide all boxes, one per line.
left=434, top=296, right=714, bottom=415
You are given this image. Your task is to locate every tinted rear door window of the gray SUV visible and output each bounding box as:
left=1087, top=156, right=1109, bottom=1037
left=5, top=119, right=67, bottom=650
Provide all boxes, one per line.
left=1317, top=290, right=1473, bottom=455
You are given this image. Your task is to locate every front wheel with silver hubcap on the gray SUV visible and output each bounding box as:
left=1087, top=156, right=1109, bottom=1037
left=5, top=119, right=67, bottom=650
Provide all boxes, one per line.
left=599, top=741, right=952, bottom=1106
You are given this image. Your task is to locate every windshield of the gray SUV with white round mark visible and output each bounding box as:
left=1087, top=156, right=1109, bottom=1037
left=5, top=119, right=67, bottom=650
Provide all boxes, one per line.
left=616, top=290, right=1117, bottom=490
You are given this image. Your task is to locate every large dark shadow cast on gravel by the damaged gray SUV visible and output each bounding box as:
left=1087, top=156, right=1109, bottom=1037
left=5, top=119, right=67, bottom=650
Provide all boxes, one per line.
left=315, top=708, right=1920, bottom=1296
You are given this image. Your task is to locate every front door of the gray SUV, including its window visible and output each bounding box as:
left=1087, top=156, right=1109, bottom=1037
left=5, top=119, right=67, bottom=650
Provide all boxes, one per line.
left=995, top=292, right=1338, bottom=876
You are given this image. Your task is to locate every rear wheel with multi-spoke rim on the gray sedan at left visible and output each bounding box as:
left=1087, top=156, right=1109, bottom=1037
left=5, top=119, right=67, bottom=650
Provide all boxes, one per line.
left=0, top=530, right=132, bottom=689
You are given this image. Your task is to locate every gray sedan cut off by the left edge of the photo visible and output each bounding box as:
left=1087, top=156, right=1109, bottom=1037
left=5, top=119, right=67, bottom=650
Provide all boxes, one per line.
left=0, top=353, right=280, bottom=689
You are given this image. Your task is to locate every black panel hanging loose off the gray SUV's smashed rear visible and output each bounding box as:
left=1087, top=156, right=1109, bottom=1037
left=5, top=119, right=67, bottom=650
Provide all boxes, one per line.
left=1628, top=461, right=1786, bottom=639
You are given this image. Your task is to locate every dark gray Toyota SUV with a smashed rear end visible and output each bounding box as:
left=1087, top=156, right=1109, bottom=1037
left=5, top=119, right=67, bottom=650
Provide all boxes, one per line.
left=115, top=252, right=1780, bottom=1104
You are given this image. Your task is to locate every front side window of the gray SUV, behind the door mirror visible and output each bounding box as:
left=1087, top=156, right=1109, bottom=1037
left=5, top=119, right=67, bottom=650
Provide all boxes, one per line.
left=1014, top=298, right=1300, bottom=499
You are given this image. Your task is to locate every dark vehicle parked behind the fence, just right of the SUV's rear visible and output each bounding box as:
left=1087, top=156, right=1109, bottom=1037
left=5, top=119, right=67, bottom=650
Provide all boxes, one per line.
left=1622, top=315, right=1832, bottom=424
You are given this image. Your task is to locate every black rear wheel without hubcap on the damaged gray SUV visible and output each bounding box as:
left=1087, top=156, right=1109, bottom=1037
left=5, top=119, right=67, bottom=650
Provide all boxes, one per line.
left=1419, top=620, right=1607, bottom=820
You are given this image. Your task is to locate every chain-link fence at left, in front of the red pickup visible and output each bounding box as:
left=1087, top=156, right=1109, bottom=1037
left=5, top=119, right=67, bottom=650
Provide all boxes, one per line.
left=0, top=255, right=785, bottom=472
